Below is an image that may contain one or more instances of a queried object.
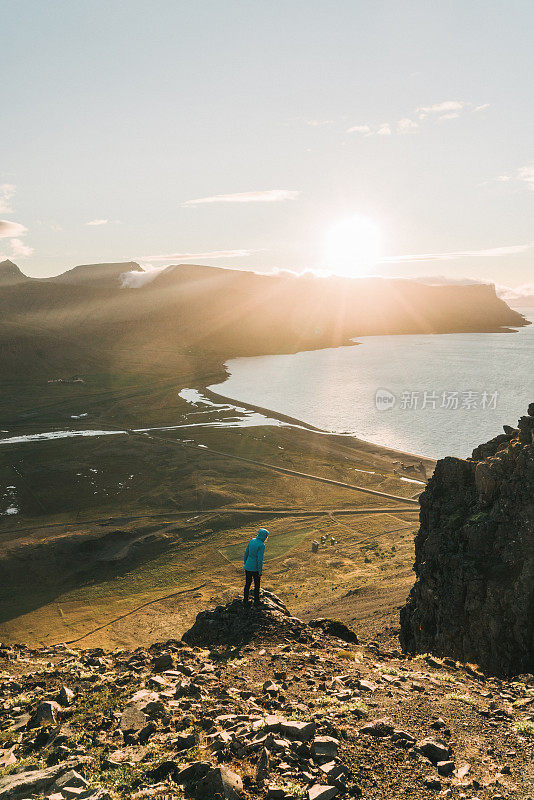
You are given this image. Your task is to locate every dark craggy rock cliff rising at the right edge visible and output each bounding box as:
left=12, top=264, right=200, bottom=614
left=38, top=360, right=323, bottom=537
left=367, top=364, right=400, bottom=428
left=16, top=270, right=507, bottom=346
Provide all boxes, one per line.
left=401, top=403, right=534, bottom=676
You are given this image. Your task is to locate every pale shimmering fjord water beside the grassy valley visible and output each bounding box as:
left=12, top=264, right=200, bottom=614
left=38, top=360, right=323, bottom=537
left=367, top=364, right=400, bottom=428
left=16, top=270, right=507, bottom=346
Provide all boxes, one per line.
left=210, top=309, right=534, bottom=458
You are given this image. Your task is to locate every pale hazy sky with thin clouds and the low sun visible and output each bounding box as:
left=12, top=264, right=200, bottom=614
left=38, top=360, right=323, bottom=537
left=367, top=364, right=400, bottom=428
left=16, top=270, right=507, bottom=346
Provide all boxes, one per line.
left=0, top=0, right=534, bottom=286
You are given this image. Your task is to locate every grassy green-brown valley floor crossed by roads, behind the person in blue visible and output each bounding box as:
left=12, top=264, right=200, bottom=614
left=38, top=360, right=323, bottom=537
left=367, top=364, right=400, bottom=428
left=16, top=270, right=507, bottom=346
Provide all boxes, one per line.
left=0, top=376, right=433, bottom=647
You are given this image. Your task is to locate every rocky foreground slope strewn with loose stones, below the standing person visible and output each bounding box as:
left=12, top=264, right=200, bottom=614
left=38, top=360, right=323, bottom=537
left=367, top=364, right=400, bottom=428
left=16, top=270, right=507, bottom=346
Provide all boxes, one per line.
left=0, top=593, right=534, bottom=800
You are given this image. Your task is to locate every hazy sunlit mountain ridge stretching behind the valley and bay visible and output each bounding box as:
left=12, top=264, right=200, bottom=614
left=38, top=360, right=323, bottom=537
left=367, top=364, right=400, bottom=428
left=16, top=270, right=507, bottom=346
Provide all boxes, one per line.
left=0, top=262, right=526, bottom=374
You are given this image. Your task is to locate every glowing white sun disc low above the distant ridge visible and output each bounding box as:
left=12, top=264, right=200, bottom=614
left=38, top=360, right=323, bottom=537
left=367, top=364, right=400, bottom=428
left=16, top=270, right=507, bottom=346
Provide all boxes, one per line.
left=325, top=214, right=381, bottom=277
